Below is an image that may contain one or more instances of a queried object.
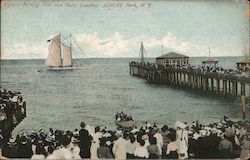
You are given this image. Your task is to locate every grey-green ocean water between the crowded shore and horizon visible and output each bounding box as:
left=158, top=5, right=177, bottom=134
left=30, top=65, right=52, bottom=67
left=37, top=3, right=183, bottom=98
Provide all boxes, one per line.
left=1, top=57, right=244, bottom=133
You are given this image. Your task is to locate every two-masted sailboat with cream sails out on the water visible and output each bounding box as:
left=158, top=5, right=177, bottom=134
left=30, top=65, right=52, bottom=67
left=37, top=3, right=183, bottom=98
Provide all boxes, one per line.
left=45, top=33, right=82, bottom=70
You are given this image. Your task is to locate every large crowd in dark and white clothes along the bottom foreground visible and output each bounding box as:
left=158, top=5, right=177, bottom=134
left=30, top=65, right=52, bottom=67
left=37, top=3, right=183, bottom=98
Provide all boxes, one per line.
left=0, top=117, right=250, bottom=159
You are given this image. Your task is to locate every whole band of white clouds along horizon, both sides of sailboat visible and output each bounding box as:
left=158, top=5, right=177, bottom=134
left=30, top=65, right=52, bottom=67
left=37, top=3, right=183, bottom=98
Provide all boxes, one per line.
left=1, top=32, right=207, bottom=59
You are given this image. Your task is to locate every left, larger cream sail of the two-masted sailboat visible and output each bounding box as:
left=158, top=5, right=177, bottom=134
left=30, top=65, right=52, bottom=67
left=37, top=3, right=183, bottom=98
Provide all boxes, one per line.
left=46, top=35, right=62, bottom=67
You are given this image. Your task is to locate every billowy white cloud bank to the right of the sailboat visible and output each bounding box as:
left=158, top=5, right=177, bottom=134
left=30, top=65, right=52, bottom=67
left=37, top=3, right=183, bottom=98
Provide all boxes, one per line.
left=76, top=32, right=193, bottom=57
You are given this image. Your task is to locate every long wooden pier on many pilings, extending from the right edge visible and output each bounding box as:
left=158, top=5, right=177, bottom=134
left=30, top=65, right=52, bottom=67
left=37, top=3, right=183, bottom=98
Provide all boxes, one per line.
left=129, top=62, right=250, bottom=99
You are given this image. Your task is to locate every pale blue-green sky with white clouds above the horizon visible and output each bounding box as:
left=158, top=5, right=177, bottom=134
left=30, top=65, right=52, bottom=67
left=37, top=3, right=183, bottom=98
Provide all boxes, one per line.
left=1, top=0, right=250, bottom=59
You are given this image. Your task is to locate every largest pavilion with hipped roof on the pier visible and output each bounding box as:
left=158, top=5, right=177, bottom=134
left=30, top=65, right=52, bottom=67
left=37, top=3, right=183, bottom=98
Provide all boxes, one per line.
left=156, top=52, right=189, bottom=66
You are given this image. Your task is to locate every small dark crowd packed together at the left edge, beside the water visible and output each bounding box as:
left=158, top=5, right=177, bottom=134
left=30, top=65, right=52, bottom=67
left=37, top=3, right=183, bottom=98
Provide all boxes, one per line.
left=0, top=87, right=25, bottom=137
